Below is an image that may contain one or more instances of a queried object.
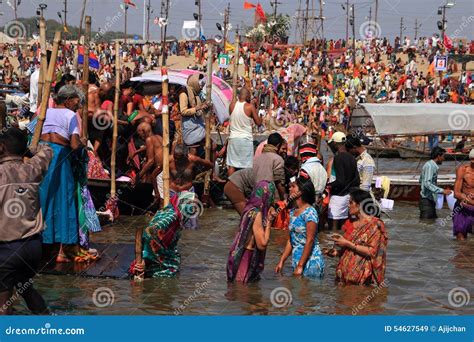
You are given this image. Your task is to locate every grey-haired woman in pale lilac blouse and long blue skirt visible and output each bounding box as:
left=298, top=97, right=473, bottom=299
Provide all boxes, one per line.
left=40, top=85, right=97, bottom=262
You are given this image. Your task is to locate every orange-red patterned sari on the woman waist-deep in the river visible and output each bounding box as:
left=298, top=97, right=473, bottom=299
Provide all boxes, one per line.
left=336, top=217, right=388, bottom=285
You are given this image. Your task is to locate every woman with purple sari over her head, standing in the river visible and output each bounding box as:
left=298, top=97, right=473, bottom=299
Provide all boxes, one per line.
left=227, top=181, right=275, bottom=283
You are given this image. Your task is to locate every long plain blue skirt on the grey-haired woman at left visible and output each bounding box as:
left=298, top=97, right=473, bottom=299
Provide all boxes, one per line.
left=40, top=142, right=79, bottom=244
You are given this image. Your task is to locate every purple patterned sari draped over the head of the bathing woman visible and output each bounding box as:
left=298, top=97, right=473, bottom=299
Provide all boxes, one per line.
left=227, top=181, right=275, bottom=283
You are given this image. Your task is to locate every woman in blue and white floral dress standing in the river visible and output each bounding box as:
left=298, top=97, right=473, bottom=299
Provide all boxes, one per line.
left=275, top=177, right=324, bottom=278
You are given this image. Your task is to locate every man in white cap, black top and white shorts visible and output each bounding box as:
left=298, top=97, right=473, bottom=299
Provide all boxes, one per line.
left=328, top=132, right=360, bottom=230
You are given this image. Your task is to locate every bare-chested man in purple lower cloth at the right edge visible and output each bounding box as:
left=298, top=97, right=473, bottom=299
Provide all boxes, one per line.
left=453, top=149, right=474, bottom=240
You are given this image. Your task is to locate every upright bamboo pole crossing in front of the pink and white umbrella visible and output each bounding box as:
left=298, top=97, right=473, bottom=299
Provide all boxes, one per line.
left=161, top=66, right=170, bottom=207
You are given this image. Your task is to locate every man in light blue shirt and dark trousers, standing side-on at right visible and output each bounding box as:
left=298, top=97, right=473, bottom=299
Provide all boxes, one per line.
left=419, top=146, right=451, bottom=219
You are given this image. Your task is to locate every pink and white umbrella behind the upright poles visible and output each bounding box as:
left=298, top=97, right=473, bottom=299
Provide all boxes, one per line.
left=131, top=69, right=233, bottom=124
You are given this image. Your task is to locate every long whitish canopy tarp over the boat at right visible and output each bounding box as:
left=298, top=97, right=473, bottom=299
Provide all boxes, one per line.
left=351, top=103, right=474, bottom=135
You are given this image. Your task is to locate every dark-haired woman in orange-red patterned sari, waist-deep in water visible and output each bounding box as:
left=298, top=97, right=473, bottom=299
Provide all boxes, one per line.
left=326, top=189, right=388, bottom=286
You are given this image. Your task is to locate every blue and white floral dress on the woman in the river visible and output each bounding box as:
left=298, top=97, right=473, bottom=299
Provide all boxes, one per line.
left=289, top=207, right=324, bottom=278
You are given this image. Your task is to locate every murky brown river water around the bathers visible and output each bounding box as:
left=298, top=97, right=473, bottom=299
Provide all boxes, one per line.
left=12, top=146, right=474, bottom=315
